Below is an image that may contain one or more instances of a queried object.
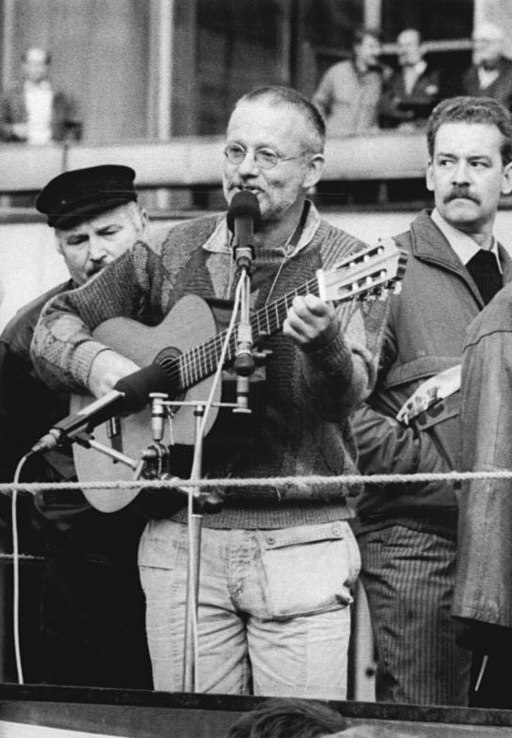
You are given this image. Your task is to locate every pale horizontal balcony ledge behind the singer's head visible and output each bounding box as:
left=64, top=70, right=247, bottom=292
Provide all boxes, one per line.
left=0, top=132, right=426, bottom=194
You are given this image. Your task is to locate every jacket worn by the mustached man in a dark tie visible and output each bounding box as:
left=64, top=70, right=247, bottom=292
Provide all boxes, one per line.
left=353, top=211, right=512, bottom=537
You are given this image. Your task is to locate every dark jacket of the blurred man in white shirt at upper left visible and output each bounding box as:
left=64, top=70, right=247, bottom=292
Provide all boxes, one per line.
left=0, top=84, right=82, bottom=142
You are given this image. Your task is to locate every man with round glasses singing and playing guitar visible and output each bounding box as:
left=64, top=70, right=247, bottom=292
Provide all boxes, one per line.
left=33, top=87, right=385, bottom=699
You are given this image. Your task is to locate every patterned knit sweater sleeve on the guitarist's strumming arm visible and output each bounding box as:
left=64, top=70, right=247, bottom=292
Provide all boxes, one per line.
left=31, top=243, right=147, bottom=392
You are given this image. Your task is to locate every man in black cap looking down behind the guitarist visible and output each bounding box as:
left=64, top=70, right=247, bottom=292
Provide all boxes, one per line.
left=0, top=165, right=151, bottom=688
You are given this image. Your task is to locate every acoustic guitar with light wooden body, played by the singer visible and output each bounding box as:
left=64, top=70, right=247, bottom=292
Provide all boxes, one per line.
left=71, top=239, right=407, bottom=513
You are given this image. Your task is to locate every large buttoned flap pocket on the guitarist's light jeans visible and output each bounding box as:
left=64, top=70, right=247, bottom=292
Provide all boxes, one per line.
left=258, top=521, right=361, bottom=619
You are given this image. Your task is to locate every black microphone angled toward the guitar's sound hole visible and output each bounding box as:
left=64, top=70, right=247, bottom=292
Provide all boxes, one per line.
left=29, top=364, right=172, bottom=455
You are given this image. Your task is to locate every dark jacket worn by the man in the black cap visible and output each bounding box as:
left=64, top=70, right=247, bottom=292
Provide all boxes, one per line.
left=0, top=280, right=144, bottom=559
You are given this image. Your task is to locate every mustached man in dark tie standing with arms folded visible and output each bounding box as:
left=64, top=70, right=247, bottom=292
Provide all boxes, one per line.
left=354, top=97, right=512, bottom=705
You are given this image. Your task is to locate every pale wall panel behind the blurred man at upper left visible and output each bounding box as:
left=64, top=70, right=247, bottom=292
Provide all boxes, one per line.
left=0, top=0, right=151, bottom=144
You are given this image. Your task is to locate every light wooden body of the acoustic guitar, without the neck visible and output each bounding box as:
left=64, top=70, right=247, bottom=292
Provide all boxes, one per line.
left=70, top=295, right=221, bottom=513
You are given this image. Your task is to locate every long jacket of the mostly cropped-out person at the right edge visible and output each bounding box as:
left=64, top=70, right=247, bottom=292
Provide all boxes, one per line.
left=453, top=278, right=512, bottom=640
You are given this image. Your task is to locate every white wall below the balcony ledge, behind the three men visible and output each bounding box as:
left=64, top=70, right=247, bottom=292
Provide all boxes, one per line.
left=0, top=210, right=512, bottom=329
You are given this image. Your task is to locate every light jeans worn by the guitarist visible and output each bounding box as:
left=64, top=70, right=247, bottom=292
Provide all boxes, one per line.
left=139, top=520, right=360, bottom=700
